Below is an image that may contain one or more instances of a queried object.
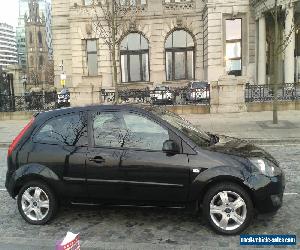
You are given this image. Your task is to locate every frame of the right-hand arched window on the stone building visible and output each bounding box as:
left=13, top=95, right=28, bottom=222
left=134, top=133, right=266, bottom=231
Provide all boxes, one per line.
left=164, top=29, right=196, bottom=81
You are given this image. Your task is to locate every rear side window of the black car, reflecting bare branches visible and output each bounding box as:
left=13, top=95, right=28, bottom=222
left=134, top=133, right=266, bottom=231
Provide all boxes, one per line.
left=33, top=113, right=87, bottom=146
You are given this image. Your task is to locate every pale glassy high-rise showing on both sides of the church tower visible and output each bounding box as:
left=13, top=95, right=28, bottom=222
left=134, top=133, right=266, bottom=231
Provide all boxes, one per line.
left=16, top=0, right=53, bottom=72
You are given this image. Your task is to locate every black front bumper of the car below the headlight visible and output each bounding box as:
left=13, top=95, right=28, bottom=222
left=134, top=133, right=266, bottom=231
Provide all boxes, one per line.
left=247, top=172, right=285, bottom=213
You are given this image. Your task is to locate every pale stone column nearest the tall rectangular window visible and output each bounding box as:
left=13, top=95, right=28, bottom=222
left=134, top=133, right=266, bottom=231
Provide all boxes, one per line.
left=257, top=15, right=266, bottom=84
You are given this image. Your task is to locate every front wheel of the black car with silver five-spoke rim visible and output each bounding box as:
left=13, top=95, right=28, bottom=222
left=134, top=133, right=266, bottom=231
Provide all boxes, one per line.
left=203, top=182, right=254, bottom=235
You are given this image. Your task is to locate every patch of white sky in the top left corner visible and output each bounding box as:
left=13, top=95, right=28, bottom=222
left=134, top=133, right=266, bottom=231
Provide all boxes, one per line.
left=0, top=0, right=19, bottom=27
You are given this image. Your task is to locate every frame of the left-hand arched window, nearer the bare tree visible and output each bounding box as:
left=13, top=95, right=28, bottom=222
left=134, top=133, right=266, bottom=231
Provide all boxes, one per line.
left=120, top=32, right=150, bottom=83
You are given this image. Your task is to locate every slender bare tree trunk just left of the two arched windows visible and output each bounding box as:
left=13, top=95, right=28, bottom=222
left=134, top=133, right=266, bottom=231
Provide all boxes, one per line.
left=111, top=0, right=119, bottom=104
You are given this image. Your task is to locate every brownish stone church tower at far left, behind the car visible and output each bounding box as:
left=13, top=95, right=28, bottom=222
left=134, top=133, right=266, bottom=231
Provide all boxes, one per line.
left=25, top=0, right=49, bottom=89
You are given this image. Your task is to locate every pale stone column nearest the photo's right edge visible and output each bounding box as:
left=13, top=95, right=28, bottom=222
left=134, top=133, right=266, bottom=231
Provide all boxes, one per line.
left=284, top=6, right=295, bottom=83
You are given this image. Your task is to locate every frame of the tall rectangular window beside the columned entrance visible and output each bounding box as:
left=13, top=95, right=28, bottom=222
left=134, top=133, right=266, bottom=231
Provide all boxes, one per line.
left=224, top=17, right=243, bottom=76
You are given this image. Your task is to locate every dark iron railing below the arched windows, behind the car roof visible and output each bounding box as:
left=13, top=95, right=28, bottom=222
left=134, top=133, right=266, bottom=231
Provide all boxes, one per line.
left=100, top=86, right=210, bottom=105
